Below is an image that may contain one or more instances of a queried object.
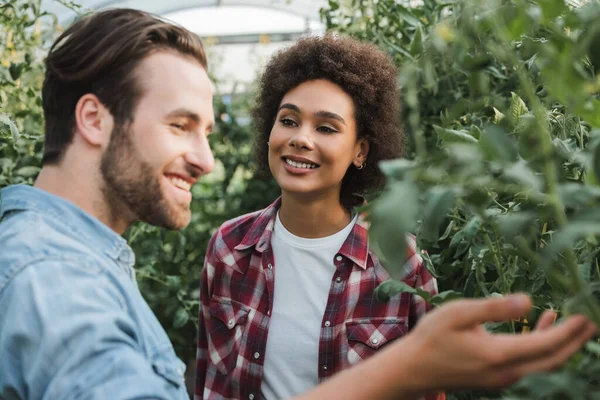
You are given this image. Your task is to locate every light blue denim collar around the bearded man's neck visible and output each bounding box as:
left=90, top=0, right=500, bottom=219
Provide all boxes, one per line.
left=0, top=185, right=135, bottom=267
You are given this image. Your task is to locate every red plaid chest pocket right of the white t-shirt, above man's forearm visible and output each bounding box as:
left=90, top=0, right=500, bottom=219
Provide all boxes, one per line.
left=346, top=317, right=408, bottom=365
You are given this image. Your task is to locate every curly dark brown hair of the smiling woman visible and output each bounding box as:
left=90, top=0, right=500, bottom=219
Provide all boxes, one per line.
left=251, top=34, right=404, bottom=209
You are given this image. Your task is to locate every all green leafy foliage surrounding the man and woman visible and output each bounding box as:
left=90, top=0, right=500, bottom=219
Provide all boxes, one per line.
left=0, top=0, right=600, bottom=399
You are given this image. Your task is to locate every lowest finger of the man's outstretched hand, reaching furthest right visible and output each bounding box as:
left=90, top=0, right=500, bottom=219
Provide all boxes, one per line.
left=514, top=322, right=596, bottom=377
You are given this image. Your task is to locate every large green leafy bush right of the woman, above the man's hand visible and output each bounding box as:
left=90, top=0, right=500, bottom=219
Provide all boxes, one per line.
left=323, top=0, right=600, bottom=399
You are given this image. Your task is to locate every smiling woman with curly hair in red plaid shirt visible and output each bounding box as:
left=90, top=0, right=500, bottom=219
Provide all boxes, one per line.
left=197, top=35, right=437, bottom=400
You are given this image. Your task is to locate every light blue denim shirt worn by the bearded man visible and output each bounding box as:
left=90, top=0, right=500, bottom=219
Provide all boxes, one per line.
left=0, top=185, right=189, bottom=400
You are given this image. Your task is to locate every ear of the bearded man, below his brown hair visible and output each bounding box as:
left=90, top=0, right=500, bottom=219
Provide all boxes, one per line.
left=75, top=93, right=113, bottom=147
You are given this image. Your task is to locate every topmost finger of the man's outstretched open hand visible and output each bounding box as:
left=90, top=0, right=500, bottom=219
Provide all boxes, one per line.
left=446, top=295, right=531, bottom=328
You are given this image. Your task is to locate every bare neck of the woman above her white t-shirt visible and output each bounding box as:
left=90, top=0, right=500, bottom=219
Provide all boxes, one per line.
left=279, top=192, right=352, bottom=239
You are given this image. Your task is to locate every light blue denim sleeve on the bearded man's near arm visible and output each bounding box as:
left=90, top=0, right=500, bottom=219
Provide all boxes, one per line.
left=0, top=260, right=176, bottom=400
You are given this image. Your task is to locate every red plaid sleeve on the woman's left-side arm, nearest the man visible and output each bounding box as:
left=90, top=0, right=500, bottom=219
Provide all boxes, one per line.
left=194, top=233, right=218, bottom=400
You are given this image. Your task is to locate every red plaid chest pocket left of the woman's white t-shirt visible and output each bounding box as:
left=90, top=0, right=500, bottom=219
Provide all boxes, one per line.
left=207, top=297, right=250, bottom=375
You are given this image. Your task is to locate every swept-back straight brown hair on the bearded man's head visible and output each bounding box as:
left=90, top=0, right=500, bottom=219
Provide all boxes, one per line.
left=42, top=8, right=207, bottom=164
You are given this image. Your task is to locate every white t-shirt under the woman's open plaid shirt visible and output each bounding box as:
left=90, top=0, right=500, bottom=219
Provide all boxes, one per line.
left=261, top=213, right=358, bottom=400
